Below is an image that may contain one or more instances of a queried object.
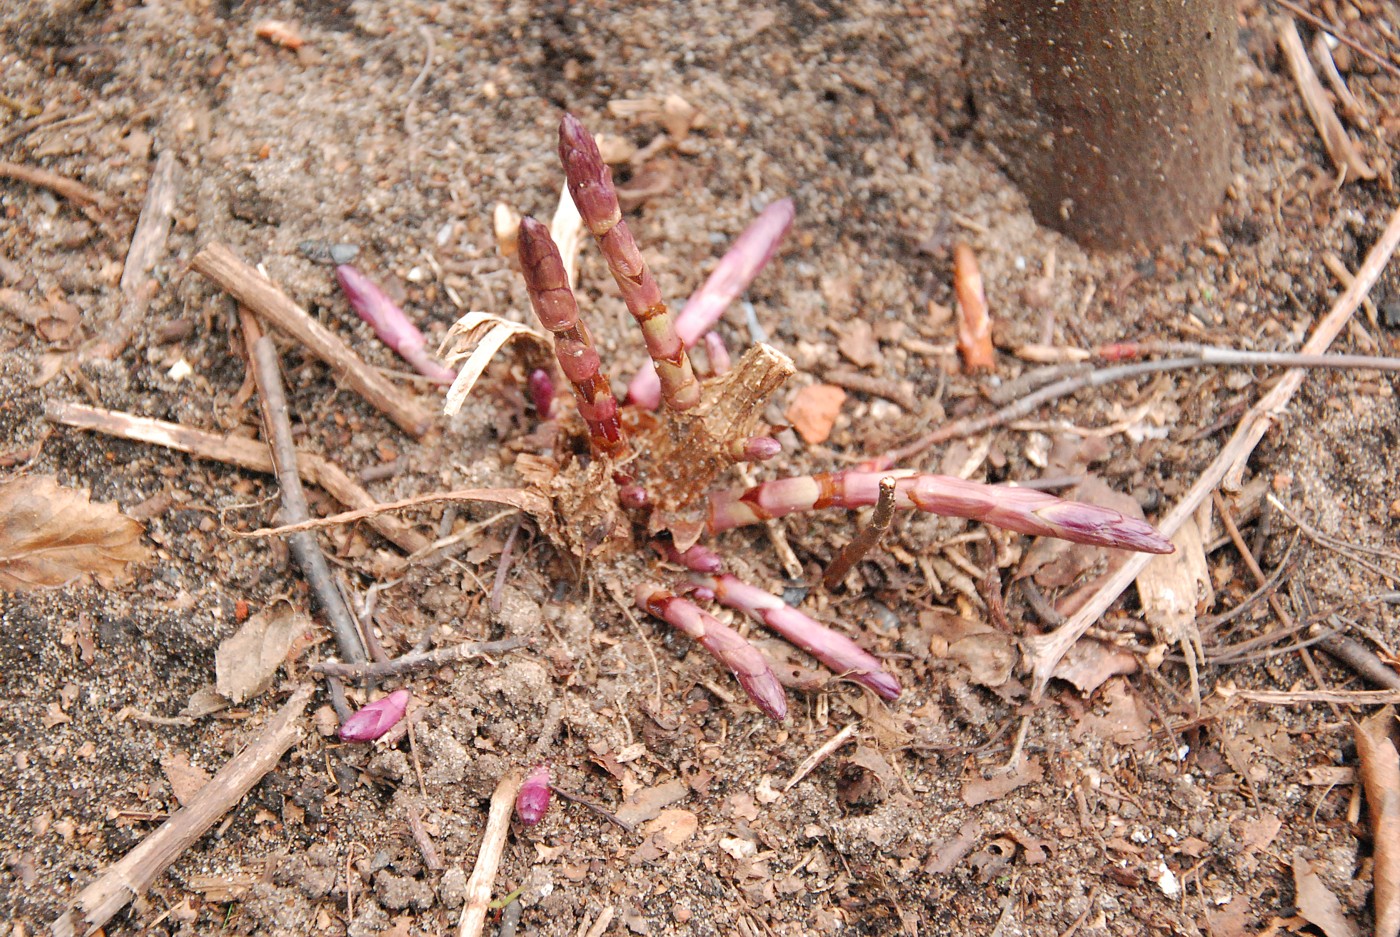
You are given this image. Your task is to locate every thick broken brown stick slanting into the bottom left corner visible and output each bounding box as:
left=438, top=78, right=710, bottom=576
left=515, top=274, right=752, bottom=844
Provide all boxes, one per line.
left=50, top=683, right=311, bottom=937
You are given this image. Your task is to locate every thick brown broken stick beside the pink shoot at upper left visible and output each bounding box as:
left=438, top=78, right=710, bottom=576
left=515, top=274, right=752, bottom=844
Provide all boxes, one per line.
left=190, top=241, right=431, bottom=436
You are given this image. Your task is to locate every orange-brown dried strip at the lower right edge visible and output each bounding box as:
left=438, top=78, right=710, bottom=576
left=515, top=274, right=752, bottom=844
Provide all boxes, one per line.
left=1357, top=706, right=1400, bottom=937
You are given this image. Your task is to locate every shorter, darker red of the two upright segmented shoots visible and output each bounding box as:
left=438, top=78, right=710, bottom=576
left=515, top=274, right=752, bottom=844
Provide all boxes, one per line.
left=518, top=217, right=626, bottom=452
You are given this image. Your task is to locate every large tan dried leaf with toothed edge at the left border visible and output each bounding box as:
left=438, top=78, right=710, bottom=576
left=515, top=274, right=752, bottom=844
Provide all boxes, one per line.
left=0, top=475, right=150, bottom=591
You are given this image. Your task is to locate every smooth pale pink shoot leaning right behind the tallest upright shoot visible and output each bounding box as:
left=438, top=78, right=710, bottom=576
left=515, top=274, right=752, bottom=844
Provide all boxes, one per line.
left=627, top=199, right=795, bottom=410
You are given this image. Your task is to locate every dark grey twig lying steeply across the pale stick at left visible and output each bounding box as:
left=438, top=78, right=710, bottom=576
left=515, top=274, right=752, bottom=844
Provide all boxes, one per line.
left=245, top=326, right=364, bottom=664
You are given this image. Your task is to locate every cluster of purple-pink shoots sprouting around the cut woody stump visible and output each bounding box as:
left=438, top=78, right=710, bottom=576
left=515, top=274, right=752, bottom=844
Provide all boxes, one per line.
left=495, top=115, right=1172, bottom=722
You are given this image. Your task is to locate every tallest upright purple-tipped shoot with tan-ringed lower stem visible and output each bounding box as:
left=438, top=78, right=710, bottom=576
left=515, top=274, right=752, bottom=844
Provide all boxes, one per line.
left=559, top=113, right=700, bottom=410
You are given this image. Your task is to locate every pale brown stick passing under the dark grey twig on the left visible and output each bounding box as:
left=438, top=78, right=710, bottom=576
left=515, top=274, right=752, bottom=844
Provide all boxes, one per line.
left=43, top=401, right=433, bottom=553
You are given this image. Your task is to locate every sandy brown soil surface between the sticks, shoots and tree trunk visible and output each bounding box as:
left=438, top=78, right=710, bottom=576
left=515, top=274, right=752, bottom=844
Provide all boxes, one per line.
left=0, top=0, right=1400, bottom=936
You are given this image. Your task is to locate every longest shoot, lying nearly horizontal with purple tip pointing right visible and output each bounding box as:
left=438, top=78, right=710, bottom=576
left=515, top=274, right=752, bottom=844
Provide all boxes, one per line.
left=708, top=469, right=1176, bottom=553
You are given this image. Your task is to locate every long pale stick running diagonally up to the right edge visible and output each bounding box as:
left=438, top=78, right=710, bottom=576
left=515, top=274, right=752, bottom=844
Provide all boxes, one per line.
left=1023, top=204, right=1400, bottom=700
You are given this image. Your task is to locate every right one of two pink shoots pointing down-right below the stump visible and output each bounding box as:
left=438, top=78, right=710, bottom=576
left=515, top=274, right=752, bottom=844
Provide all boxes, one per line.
left=694, top=573, right=900, bottom=699
